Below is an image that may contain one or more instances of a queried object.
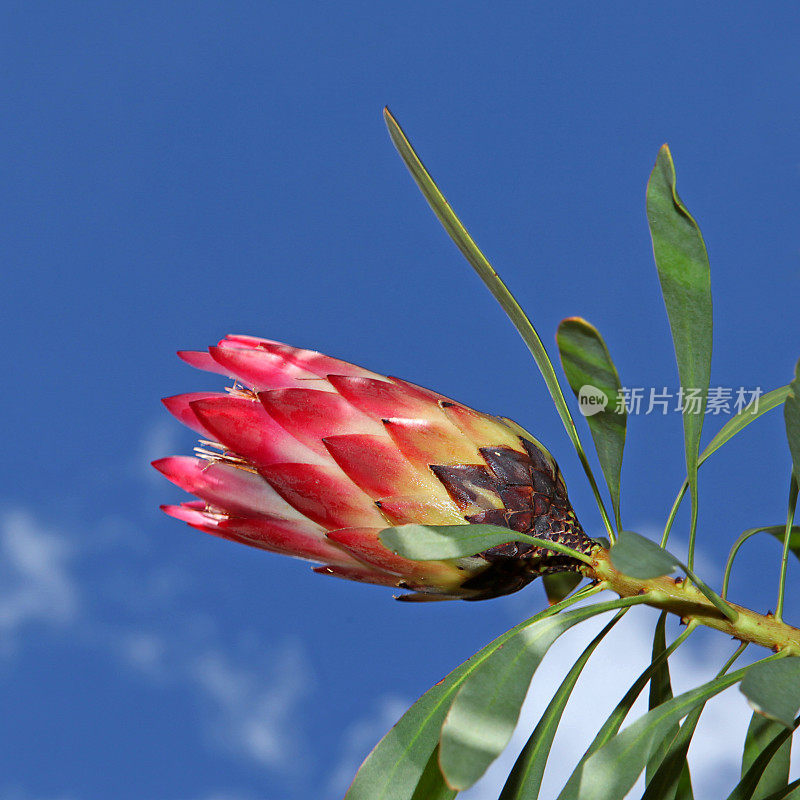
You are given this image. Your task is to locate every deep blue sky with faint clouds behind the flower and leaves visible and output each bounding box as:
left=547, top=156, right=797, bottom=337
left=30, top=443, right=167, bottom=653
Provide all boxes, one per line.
left=0, top=2, right=800, bottom=800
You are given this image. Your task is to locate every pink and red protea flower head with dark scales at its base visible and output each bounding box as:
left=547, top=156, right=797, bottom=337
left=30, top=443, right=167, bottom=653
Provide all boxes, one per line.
left=153, top=336, right=593, bottom=600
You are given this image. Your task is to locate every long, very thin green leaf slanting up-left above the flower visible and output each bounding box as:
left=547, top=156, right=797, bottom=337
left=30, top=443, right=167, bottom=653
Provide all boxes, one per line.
left=383, top=108, right=613, bottom=537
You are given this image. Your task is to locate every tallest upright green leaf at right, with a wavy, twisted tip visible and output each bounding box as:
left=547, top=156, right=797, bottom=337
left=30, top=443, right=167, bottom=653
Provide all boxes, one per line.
left=647, top=145, right=712, bottom=567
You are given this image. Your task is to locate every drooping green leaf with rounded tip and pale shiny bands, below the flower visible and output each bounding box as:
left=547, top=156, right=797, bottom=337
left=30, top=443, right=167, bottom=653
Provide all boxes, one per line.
left=439, top=597, right=645, bottom=790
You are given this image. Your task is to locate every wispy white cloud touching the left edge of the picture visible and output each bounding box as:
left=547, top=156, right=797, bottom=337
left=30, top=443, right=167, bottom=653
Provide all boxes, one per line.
left=0, top=511, right=78, bottom=642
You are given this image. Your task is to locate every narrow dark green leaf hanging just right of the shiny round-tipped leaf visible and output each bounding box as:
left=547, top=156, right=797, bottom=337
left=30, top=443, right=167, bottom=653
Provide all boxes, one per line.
left=500, top=609, right=627, bottom=800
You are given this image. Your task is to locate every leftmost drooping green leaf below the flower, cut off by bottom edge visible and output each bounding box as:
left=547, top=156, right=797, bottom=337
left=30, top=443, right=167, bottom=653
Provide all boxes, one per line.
left=345, top=598, right=600, bottom=800
